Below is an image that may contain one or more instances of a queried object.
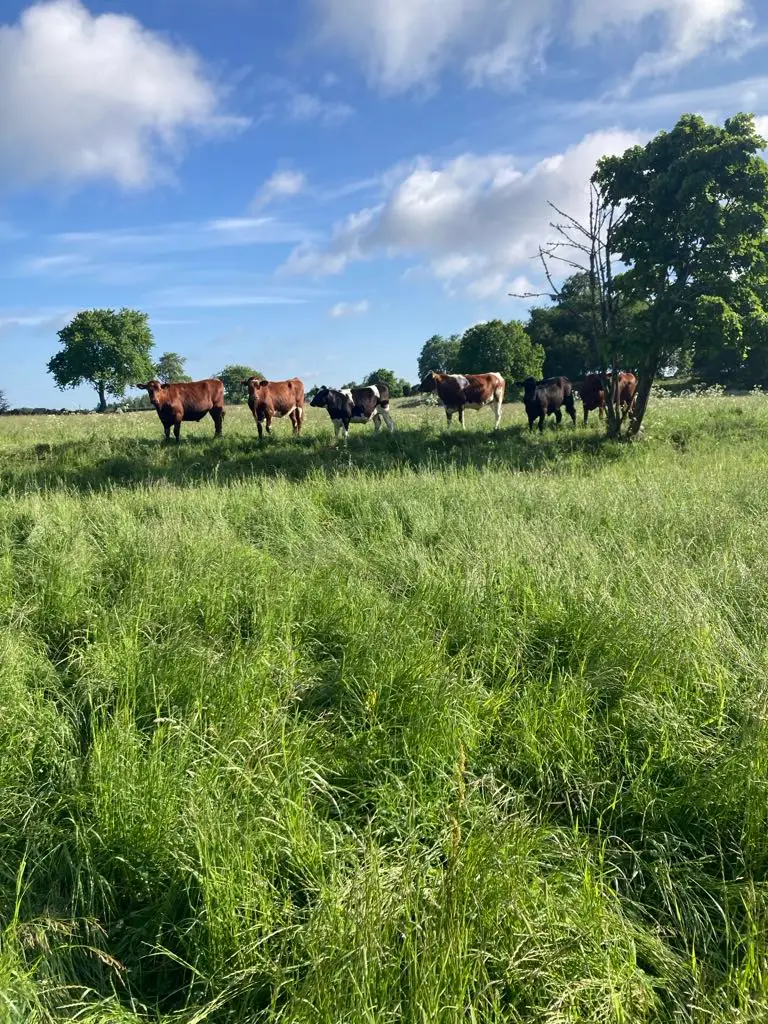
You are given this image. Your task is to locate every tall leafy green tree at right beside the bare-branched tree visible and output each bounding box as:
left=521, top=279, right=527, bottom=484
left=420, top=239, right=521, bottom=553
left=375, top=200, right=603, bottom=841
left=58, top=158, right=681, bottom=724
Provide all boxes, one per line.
left=593, top=114, right=768, bottom=433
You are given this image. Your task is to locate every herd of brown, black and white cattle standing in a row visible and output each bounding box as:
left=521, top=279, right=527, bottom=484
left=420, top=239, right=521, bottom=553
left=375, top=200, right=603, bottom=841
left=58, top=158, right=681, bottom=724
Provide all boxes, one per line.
left=135, top=373, right=637, bottom=441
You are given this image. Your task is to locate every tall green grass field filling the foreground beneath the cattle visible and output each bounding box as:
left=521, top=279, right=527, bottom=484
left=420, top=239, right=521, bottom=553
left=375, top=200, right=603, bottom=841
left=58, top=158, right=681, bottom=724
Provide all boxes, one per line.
left=0, top=396, right=768, bottom=1024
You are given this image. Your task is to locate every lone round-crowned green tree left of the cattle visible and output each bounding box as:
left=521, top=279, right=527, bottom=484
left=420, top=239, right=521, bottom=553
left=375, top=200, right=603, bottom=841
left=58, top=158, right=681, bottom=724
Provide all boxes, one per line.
left=48, top=308, right=155, bottom=413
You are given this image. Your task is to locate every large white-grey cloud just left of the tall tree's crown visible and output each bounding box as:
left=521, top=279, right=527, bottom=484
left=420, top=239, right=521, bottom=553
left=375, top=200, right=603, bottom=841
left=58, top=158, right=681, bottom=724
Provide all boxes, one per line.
left=283, top=130, right=641, bottom=298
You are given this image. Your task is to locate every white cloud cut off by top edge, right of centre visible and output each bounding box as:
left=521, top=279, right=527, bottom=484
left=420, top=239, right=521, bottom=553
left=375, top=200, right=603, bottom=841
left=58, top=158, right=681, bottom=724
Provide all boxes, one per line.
left=314, top=0, right=749, bottom=92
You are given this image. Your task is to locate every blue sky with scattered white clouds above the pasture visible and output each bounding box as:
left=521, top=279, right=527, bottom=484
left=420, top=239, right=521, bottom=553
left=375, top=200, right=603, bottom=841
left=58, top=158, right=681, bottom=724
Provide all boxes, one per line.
left=0, top=0, right=768, bottom=408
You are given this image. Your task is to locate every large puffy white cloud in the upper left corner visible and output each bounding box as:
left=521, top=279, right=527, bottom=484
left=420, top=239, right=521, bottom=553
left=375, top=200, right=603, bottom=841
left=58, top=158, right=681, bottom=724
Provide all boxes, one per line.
left=0, top=0, right=243, bottom=187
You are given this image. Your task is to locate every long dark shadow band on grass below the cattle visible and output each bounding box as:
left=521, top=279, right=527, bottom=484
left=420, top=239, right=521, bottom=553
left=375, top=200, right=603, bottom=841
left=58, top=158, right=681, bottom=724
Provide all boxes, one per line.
left=0, top=425, right=623, bottom=494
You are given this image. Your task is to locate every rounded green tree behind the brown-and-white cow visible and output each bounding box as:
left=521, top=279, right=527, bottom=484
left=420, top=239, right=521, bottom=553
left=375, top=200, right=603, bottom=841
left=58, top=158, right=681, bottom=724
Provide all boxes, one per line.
left=456, top=319, right=544, bottom=385
